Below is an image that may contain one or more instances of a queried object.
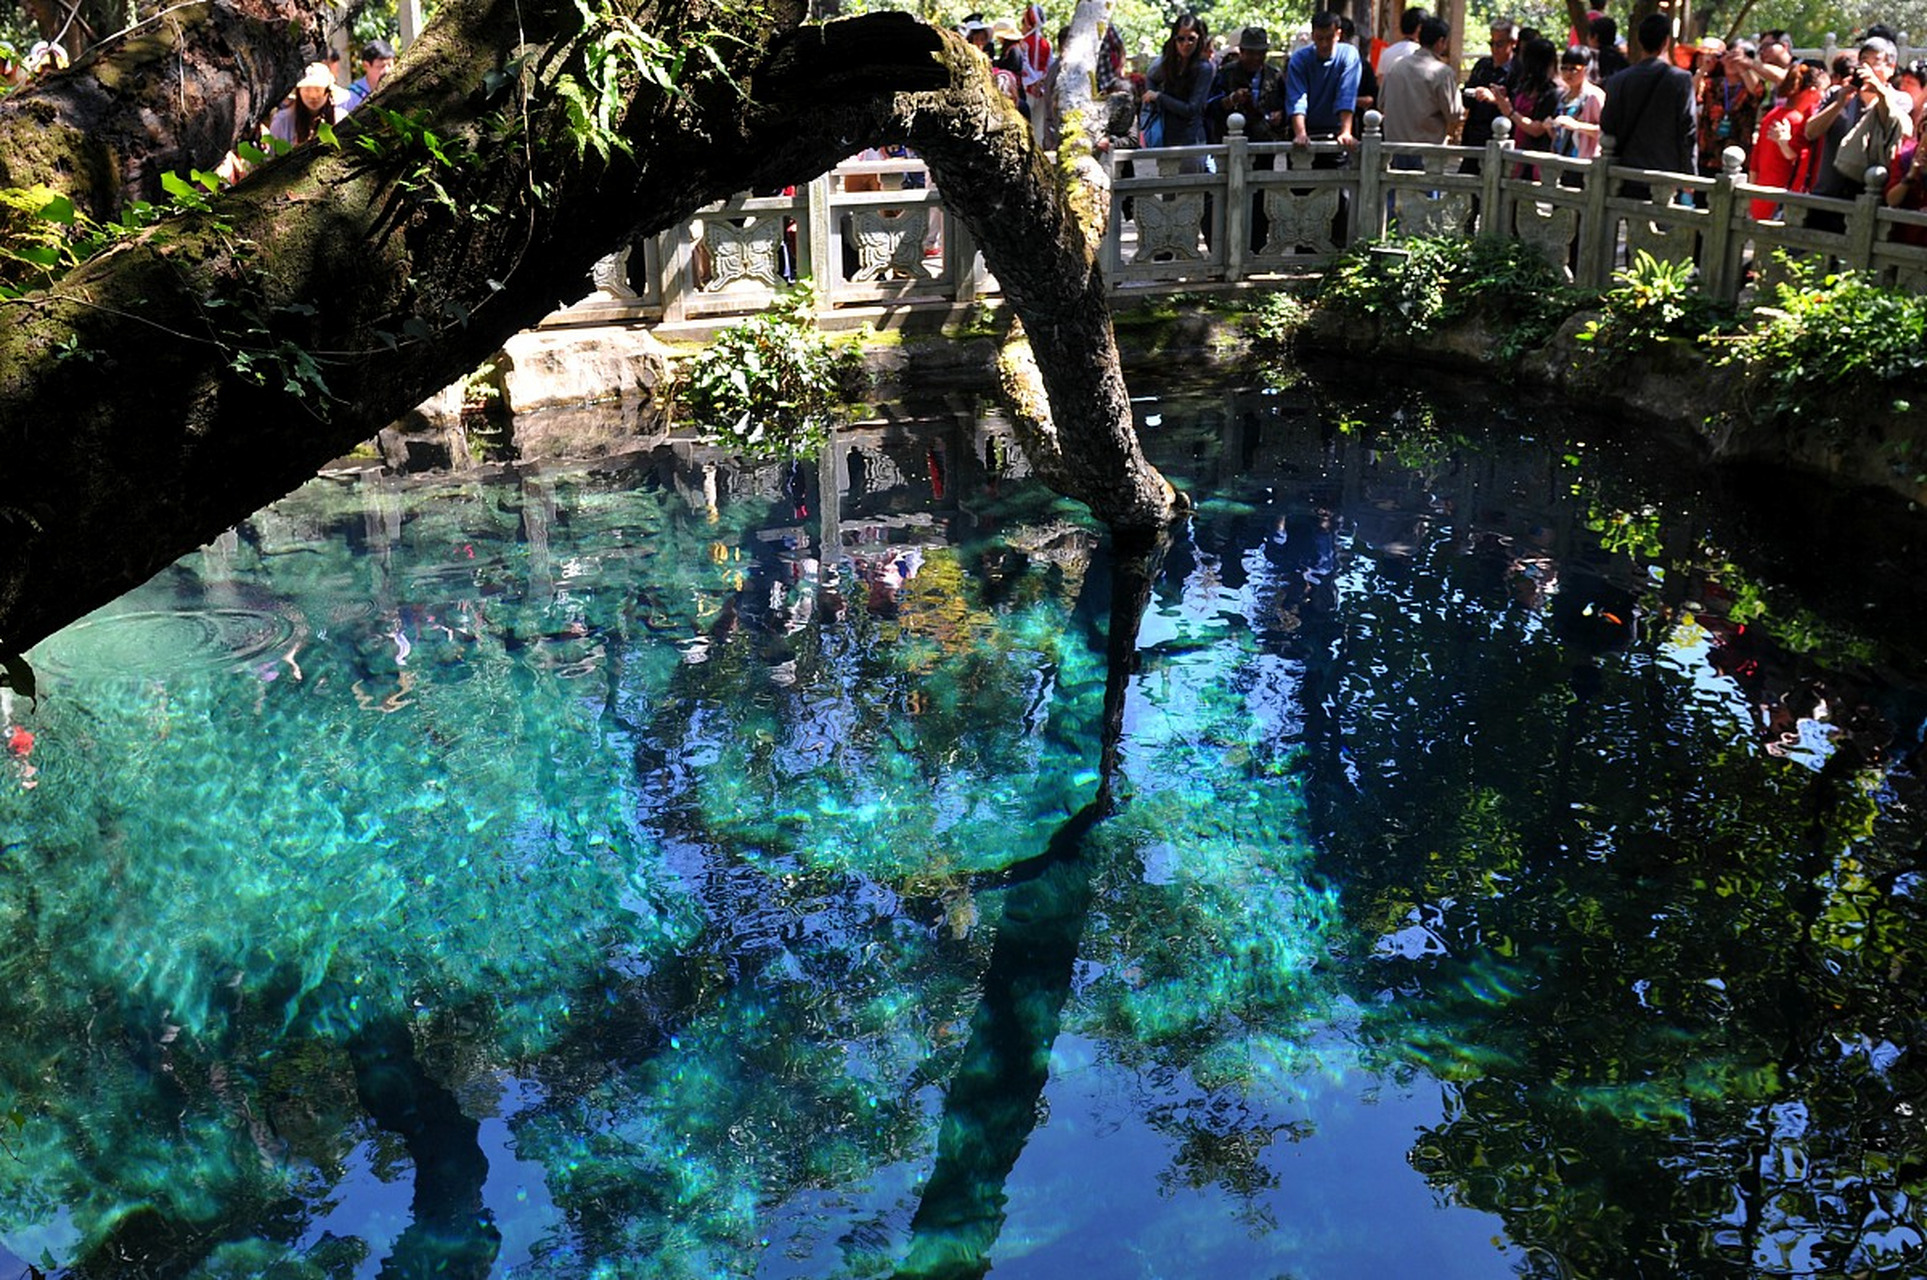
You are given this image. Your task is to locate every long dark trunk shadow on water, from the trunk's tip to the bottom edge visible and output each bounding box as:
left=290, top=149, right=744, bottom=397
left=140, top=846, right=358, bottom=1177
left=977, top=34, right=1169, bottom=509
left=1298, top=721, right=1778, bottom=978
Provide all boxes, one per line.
left=896, top=536, right=1168, bottom=1280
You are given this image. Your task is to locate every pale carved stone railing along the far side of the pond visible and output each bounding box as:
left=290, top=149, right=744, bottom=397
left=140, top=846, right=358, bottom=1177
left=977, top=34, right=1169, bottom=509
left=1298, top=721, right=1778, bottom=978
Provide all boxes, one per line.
left=545, top=112, right=1927, bottom=328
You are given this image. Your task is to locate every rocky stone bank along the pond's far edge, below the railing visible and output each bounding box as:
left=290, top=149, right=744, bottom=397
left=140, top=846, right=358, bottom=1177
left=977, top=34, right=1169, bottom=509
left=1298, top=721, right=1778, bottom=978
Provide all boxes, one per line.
left=362, top=299, right=1927, bottom=507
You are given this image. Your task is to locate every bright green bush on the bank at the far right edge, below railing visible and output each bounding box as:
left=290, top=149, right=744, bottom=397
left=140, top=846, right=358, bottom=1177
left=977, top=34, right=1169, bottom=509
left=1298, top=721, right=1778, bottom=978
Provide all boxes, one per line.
left=1723, top=254, right=1927, bottom=435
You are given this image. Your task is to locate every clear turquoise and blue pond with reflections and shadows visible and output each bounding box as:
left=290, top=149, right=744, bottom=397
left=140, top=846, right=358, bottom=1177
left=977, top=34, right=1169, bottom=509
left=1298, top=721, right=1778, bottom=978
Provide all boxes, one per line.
left=0, top=372, right=1927, bottom=1280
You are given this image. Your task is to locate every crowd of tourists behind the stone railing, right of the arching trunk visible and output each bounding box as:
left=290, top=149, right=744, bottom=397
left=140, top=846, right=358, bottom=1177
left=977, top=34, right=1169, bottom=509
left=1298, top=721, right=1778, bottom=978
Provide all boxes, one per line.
left=1112, top=8, right=1927, bottom=226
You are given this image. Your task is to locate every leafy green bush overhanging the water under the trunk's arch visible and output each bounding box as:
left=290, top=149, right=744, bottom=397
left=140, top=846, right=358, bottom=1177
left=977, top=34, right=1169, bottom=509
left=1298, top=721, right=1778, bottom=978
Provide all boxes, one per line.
left=678, top=283, right=858, bottom=459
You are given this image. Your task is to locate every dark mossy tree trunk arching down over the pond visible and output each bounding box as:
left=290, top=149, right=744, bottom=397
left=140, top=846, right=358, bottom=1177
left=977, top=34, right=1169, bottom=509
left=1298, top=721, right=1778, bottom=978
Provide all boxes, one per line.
left=0, top=0, right=1172, bottom=653
